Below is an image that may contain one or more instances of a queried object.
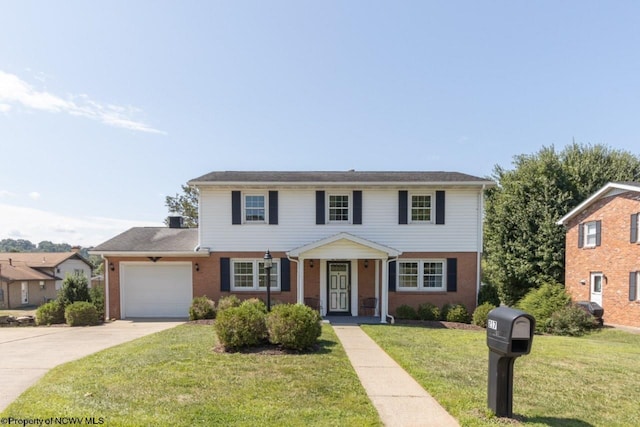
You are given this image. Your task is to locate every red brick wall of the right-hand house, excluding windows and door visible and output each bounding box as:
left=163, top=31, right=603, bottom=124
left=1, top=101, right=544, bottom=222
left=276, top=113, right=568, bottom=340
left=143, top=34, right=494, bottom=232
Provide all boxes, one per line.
left=565, top=191, right=640, bottom=327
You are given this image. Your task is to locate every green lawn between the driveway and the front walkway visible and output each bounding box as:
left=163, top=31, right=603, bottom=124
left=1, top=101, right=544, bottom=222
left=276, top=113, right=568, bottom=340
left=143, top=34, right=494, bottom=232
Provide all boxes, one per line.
left=2, top=324, right=380, bottom=426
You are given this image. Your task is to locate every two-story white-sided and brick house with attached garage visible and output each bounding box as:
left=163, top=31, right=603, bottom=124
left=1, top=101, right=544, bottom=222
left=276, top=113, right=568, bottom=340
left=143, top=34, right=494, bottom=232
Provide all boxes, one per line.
left=91, top=171, right=495, bottom=322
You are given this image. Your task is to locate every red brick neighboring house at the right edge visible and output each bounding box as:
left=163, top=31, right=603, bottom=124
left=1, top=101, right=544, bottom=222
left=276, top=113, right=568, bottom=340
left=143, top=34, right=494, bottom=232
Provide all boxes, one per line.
left=558, top=182, right=640, bottom=327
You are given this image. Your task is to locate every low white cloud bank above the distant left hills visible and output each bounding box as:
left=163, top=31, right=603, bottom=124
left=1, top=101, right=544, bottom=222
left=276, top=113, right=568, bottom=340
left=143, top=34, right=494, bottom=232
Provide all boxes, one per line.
left=0, top=204, right=163, bottom=247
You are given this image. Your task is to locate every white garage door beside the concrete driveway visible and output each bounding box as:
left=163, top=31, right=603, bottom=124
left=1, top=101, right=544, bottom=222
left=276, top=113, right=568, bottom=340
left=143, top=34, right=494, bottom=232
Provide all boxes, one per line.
left=120, top=262, right=193, bottom=318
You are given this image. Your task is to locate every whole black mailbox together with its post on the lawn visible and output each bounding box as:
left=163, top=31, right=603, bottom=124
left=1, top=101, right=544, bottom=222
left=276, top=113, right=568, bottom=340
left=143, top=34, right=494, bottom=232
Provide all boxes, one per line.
left=487, top=307, right=535, bottom=418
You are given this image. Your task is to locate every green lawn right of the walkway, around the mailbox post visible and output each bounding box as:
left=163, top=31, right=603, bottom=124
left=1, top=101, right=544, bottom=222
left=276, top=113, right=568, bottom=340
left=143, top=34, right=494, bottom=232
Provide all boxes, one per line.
left=363, top=325, right=640, bottom=427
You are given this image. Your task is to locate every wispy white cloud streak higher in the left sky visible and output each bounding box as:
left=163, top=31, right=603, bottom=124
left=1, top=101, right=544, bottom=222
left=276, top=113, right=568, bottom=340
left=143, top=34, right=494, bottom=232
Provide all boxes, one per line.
left=0, top=71, right=166, bottom=134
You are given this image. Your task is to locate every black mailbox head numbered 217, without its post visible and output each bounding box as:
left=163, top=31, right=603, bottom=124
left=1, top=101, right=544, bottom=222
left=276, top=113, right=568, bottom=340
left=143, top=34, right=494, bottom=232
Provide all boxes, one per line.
left=487, top=307, right=536, bottom=356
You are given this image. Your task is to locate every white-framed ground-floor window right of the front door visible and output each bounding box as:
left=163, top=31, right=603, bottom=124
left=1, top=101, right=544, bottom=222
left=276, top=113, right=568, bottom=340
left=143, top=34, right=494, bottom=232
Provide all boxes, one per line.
left=398, top=260, right=447, bottom=291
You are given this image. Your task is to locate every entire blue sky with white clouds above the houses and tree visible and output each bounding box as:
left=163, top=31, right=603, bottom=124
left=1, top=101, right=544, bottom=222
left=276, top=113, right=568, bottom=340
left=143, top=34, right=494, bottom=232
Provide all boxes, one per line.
left=0, top=0, right=640, bottom=246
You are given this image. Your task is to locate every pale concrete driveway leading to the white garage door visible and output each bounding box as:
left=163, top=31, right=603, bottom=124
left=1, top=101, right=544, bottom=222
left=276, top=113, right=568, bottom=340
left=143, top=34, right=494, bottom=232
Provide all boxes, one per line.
left=0, top=320, right=184, bottom=412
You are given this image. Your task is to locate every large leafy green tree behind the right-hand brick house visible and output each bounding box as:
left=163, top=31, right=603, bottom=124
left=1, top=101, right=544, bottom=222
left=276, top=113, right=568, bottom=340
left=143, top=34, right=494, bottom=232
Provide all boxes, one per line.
left=484, top=143, right=640, bottom=305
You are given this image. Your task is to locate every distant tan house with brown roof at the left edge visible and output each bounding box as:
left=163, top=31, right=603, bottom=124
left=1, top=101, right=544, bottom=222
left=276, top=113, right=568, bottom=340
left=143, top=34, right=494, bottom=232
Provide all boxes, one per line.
left=0, top=251, right=91, bottom=309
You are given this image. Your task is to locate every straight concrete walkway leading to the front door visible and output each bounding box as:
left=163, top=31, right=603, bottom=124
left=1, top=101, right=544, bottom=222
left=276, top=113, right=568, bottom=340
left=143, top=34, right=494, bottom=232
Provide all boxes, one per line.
left=333, top=325, right=460, bottom=427
